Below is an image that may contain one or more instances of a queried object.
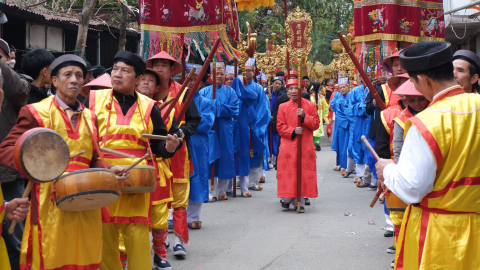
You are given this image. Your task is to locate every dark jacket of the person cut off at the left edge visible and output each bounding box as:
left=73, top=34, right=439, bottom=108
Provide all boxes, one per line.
left=0, top=62, right=33, bottom=183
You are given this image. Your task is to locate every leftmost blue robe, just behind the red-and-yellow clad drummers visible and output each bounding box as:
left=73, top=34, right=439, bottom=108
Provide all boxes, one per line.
left=189, top=92, right=216, bottom=203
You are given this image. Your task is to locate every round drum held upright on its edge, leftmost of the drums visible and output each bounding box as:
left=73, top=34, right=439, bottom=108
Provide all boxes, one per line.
left=13, top=128, right=70, bottom=183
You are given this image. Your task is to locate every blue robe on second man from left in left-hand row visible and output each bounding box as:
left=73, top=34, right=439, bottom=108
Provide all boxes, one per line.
left=199, top=85, right=240, bottom=179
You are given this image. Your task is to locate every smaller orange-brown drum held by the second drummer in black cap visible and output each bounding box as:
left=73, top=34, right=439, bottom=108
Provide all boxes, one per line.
left=118, top=165, right=157, bottom=194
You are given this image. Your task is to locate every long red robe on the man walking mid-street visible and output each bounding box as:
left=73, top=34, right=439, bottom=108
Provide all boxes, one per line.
left=277, top=98, right=320, bottom=198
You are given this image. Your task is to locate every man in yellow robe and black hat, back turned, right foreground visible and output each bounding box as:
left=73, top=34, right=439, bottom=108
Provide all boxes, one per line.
left=376, top=41, right=480, bottom=269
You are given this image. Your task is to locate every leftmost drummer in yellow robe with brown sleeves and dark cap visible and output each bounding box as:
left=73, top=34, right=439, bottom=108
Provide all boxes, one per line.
left=0, top=54, right=124, bottom=270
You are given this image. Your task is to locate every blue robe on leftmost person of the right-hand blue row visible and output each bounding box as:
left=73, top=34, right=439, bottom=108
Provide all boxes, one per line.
left=330, top=93, right=350, bottom=168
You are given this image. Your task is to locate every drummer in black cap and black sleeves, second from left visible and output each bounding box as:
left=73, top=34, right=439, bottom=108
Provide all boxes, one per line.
left=85, top=51, right=181, bottom=270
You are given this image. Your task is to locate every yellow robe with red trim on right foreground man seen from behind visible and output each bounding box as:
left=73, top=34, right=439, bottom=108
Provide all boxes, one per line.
left=395, top=87, right=480, bottom=269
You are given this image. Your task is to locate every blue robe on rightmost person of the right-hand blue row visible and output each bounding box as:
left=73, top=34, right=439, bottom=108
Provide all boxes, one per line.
left=345, top=85, right=371, bottom=164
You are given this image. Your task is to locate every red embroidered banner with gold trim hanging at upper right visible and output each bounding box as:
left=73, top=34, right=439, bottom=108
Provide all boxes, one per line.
left=354, top=0, right=445, bottom=43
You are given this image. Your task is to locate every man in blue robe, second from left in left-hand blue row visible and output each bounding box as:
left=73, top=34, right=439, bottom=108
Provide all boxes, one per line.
left=199, top=63, right=239, bottom=202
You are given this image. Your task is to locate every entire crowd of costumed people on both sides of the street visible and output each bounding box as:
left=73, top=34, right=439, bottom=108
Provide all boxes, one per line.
left=0, top=35, right=480, bottom=269
